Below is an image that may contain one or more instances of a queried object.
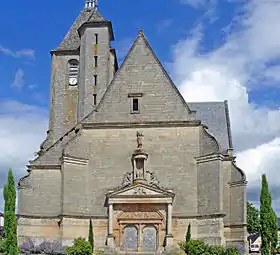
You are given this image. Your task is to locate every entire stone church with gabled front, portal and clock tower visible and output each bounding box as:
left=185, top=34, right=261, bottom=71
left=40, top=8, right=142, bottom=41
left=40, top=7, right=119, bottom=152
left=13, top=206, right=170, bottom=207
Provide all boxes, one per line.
left=18, top=1, right=247, bottom=253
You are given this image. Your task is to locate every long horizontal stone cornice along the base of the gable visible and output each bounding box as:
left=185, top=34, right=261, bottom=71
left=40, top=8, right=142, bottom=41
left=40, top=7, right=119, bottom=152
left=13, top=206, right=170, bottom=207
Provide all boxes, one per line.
left=82, top=120, right=201, bottom=129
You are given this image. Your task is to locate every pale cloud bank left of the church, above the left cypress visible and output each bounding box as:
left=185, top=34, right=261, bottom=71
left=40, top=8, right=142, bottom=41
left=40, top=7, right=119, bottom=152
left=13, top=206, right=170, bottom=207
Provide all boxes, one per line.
left=0, top=100, right=48, bottom=211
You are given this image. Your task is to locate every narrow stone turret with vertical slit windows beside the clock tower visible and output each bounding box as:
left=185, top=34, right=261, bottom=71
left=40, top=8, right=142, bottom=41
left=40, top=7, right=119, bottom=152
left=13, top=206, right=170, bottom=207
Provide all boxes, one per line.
left=78, top=0, right=114, bottom=121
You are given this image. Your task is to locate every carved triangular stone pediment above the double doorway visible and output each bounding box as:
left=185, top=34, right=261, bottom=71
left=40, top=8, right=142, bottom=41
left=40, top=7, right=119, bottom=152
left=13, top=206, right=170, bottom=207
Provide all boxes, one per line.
left=107, top=184, right=174, bottom=197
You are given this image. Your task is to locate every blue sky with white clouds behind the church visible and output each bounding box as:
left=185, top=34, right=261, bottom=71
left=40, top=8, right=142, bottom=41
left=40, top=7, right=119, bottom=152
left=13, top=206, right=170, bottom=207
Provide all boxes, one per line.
left=0, top=0, right=280, bottom=216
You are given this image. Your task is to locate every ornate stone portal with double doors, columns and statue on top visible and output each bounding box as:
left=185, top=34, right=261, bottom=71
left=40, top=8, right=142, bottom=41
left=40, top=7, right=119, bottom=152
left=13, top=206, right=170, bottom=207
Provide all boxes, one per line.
left=107, top=132, right=175, bottom=253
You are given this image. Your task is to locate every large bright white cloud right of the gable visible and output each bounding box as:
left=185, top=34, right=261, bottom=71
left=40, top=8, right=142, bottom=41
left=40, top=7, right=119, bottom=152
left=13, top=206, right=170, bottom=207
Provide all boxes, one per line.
left=171, top=0, right=280, bottom=212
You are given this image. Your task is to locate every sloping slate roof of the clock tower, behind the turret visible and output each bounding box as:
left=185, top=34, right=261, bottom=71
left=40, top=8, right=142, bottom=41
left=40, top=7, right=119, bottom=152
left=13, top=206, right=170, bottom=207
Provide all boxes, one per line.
left=56, top=9, right=108, bottom=51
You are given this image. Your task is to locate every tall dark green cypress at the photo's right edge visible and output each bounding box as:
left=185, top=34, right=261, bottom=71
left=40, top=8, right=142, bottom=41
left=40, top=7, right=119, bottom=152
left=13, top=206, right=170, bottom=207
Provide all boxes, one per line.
left=260, top=174, right=278, bottom=255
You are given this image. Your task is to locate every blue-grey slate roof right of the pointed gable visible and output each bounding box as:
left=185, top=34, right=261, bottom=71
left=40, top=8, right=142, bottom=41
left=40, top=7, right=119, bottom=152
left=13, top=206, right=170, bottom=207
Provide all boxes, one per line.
left=188, top=101, right=233, bottom=153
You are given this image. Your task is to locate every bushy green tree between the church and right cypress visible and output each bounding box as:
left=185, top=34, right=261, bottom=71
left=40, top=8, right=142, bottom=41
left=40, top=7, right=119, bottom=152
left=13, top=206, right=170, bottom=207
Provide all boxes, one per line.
left=247, top=202, right=260, bottom=234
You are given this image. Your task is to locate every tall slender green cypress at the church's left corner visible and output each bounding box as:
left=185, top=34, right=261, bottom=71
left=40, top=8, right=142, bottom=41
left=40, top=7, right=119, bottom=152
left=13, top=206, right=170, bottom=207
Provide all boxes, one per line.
left=3, top=169, right=18, bottom=255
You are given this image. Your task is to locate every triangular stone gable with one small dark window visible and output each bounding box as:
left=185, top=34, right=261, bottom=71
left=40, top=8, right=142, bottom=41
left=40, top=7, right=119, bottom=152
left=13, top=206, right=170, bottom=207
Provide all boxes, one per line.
left=85, top=32, right=193, bottom=123
